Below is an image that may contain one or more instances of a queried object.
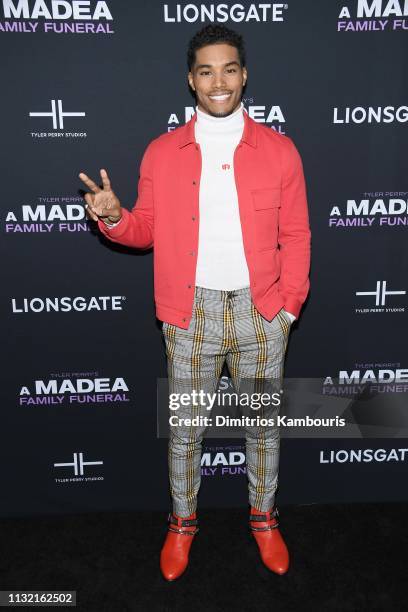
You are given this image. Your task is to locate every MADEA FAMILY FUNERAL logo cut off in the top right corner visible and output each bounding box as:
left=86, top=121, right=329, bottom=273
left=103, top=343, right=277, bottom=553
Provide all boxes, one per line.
left=337, top=0, right=408, bottom=32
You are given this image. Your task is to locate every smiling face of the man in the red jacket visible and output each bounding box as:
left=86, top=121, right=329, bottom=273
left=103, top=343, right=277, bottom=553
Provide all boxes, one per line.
left=188, top=43, right=247, bottom=117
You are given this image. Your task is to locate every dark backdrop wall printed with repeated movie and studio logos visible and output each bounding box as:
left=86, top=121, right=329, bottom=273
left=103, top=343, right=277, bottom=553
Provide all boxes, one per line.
left=0, top=0, right=408, bottom=516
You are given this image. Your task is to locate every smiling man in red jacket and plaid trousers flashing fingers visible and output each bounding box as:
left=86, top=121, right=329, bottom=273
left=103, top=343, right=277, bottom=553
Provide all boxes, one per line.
left=79, top=24, right=310, bottom=580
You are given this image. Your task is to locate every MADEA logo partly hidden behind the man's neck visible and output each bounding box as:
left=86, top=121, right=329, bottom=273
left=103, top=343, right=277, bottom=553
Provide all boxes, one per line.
left=167, top=97, right=286, bottom=134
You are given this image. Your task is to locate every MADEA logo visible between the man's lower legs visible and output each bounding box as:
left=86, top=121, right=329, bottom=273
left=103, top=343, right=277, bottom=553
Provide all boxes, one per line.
left=201, top=444, right=246, bottom=476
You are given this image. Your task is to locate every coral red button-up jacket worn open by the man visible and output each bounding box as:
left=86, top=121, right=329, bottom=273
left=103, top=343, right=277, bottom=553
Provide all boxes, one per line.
left=98, top=111, right=311, bottom=329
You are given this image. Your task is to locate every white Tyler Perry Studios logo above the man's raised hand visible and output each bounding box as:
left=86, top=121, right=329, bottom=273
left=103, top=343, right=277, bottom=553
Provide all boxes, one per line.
left=28, top=100, right=87, bottom=140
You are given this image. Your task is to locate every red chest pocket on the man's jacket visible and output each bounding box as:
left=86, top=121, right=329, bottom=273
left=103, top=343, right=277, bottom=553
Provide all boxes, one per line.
left=251, top=188, right=281, bottom=251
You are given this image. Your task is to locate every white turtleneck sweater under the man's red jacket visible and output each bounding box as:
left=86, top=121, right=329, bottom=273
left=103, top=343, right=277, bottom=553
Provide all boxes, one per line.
left=194, top=102, right=250, bottom=290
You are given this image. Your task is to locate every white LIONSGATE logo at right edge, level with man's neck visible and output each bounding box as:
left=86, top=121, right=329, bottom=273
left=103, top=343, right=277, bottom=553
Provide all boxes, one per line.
left=333, top=104, right=408, bottom=125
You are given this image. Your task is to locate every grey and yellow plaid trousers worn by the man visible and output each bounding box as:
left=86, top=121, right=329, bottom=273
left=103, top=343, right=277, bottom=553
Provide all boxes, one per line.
left=162, top=286, right=291, bottom=517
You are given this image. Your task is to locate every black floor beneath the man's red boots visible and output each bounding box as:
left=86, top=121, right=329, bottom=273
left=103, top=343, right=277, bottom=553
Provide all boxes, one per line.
left=0, top=503, right=408, bottom=612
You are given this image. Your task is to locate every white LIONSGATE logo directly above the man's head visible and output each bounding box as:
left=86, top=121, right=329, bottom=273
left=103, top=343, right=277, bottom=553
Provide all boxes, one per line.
left=163, top=2, right=288, bottom=23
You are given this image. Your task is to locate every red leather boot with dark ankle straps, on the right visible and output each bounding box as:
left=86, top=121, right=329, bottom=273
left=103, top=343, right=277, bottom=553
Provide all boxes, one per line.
left=249, top=506, right=289, bottom=574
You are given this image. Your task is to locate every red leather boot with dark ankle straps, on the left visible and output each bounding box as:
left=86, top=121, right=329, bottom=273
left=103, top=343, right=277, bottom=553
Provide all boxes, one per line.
left=160, top=512, right=198, bottom=581
